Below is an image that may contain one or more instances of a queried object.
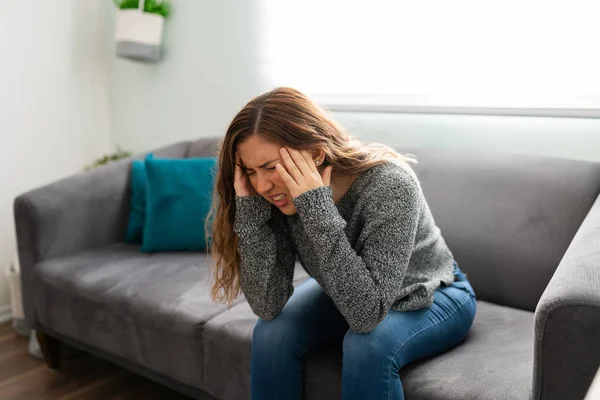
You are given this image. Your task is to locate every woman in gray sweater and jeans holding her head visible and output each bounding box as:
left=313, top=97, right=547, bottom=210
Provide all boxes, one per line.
left=212, top=88, right=476, bottom=400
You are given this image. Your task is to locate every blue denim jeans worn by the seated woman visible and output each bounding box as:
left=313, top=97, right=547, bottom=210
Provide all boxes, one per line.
left=250, top=266, right=476, bottom=400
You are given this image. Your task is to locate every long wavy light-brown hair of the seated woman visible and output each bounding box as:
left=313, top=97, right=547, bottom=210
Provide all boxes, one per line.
left=207, top=87, right=412, bottom=305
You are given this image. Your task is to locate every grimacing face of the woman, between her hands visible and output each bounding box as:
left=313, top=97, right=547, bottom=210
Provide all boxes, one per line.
left=237, top=135, right=297, bottom=215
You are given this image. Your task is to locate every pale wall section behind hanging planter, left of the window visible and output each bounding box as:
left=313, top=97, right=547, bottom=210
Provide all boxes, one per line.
left=105, top=0, right=260, bottom=151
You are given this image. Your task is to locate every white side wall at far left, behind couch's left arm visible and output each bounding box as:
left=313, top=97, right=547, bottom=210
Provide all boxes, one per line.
left=0, top=0, right=112, bottom=318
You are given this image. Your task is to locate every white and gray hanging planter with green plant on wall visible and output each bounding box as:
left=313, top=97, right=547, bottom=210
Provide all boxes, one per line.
left=113, top=0, right=171, bottom=61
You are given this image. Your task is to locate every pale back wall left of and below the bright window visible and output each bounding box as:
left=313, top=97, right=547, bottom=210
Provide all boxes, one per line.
left=106, top=0, right=600, bottom=161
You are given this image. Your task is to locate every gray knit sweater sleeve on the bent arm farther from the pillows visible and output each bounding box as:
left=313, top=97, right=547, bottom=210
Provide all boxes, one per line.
left=294, top=170, right=422, bottom=333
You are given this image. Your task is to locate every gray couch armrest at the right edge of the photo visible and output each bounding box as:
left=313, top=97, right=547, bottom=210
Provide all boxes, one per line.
left=533, top=197, right=600, bottom=400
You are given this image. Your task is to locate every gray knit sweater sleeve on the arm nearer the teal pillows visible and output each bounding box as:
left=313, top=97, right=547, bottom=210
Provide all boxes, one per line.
left=233, top=196, right=296, bottom=321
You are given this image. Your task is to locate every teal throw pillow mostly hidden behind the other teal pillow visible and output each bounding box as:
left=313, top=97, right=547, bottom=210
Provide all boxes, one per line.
left=125, top=154, right=152, bottom=244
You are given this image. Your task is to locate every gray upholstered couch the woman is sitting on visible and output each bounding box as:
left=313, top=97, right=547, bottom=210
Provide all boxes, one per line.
left=14, top=139, right=600, bottom=400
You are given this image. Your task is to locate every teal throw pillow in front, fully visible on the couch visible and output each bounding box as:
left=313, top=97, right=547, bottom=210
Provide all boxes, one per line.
left=142, top=157, right=217, bottom=253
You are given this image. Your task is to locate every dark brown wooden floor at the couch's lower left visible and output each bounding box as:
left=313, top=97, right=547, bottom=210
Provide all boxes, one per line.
left=0, top=323, right=190, bottom=400
